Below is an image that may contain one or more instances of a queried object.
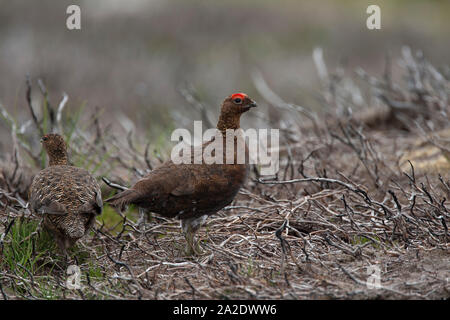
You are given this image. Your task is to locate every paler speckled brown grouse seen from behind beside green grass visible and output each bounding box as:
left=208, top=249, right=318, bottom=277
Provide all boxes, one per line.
left=30, top=134, right=103, bottom=254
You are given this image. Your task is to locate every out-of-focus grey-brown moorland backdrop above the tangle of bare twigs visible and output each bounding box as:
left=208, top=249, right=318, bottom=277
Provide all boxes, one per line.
left=0, top=0, right=450, bottom=151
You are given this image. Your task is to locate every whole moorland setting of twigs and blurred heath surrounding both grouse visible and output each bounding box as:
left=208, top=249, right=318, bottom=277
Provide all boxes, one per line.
left=0, top=0, right=450, bottom=300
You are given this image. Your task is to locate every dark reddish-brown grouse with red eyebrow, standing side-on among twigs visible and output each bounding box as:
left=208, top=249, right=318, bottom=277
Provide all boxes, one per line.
left=106, top=93, right=256, bottom=254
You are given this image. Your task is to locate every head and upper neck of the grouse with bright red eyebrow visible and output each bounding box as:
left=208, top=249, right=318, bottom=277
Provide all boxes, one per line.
left=217, top=93, right=256, bottom=131
